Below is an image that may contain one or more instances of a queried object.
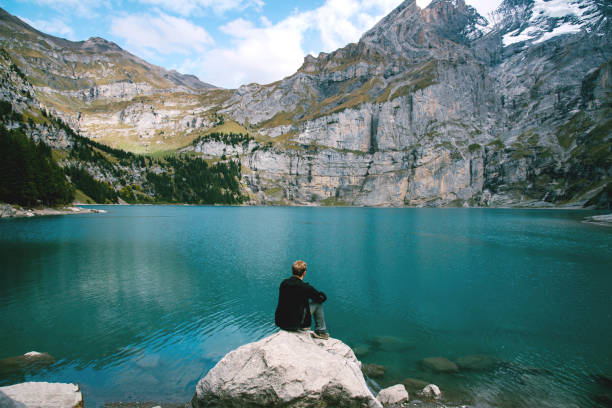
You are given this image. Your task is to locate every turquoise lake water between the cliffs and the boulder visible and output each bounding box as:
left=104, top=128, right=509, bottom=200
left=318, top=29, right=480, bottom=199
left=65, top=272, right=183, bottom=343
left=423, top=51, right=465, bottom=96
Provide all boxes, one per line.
left=0, top=206, right=612, bottom=407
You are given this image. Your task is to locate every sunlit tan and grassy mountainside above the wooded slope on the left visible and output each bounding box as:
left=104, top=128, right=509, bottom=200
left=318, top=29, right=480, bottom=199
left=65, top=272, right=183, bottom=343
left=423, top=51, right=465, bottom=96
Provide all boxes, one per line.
left=0, top=9, right=226, bottom=152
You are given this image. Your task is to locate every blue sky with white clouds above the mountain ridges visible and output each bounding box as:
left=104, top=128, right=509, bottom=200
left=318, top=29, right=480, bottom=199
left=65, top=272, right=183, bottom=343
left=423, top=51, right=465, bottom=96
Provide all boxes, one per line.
left=0, top=0, right=500, bottom=88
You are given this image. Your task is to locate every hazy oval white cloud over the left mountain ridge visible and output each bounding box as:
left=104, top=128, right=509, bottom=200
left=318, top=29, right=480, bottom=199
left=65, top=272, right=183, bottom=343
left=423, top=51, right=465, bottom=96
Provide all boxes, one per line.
left=110, top=12, right=213, bottom=55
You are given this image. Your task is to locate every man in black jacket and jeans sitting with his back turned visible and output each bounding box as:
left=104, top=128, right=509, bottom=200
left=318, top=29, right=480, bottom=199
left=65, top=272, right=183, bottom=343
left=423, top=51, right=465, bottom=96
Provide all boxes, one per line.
left=274, top=261, right=329, bottom=340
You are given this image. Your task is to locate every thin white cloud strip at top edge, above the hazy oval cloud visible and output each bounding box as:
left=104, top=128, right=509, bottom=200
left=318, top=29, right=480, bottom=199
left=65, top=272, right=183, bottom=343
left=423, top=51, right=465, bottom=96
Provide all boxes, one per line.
left=139, top=0, right=264, bottom=16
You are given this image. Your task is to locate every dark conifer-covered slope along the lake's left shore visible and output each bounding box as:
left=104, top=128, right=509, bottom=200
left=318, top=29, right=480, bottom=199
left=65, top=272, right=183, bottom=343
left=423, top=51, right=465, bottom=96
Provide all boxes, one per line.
left=0, top=49, right=243, bottom=206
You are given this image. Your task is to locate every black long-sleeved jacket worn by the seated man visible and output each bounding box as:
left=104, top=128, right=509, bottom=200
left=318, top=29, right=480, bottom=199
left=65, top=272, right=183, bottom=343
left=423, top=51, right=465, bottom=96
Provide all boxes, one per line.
left=274, top=276, right=327, bottom=330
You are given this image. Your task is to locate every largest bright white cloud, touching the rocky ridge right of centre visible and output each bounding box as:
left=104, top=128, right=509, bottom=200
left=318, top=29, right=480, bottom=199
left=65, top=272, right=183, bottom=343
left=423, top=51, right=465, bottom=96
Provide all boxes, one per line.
left=184, top=0, right=402, bottom=88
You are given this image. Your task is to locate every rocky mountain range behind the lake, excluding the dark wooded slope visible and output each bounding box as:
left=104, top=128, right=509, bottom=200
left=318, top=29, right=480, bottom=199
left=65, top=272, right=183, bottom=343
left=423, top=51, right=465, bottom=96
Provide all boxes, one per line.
left=0, top=0, right=612, bottom=208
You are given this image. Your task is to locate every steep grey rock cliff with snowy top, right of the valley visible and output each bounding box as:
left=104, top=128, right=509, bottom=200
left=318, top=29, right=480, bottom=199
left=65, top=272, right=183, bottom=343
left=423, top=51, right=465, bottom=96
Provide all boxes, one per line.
left=210, top=0, right=612, bottom=206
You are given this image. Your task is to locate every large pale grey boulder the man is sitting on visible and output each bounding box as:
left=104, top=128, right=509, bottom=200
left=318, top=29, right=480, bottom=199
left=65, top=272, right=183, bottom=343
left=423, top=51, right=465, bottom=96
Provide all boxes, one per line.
left=191, top=330, right=381, bottom=408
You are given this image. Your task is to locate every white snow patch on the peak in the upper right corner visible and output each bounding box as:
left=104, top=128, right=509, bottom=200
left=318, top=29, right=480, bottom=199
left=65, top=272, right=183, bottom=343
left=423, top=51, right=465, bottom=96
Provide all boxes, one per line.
left=502, top=0, right=605, bottom=47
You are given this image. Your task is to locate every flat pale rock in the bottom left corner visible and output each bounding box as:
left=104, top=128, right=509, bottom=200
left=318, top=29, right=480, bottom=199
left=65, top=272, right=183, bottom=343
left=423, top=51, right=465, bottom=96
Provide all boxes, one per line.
left=0, top=382, right=83, bottom=408
